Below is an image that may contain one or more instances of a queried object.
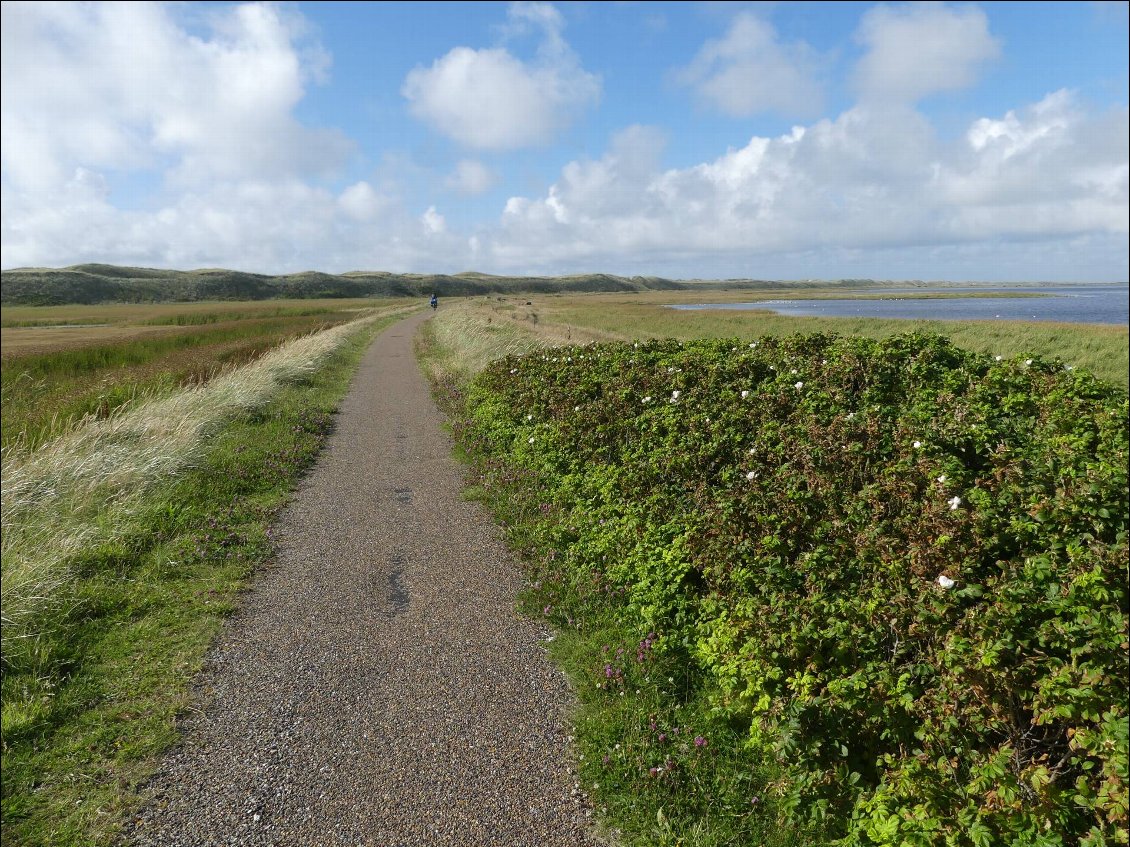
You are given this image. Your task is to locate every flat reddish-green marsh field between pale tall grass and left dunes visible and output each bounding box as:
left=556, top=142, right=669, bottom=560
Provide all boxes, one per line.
left=0, top=300, right=410, bottom=449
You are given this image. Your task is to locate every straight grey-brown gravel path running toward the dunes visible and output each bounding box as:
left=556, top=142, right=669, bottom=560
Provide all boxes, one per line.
left=125, top=315, right=599, bottom=847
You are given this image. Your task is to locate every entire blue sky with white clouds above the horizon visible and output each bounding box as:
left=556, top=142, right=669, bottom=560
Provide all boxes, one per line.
left=0, top=1, right=1130, bottom=282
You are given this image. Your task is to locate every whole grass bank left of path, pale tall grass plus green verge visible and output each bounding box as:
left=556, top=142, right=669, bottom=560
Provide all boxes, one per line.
left=0, top=302, right=403, bottom=845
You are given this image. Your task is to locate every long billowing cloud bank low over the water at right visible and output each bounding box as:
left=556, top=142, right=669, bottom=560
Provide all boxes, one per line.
left=493, top=91, right=1130, bottom=273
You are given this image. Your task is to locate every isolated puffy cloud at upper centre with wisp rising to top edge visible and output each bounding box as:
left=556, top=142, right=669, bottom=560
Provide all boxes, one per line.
left=401, top=3, right=600, bottom=150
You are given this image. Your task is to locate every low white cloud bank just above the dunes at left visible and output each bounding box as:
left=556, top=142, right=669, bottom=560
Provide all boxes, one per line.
left=2, top=175, right=471, bottom=273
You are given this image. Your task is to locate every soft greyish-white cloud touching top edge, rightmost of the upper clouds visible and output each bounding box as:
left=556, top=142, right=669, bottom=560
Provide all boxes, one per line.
left=855, top=3, right=1000, bottom=103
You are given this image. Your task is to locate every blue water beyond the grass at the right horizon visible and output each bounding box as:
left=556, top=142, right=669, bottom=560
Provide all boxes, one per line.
left=670, top=285, right=1130, bottom=326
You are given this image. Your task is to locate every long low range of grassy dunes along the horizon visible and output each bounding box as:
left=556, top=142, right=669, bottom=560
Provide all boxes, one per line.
left=0, top=264, right=871, bottom=306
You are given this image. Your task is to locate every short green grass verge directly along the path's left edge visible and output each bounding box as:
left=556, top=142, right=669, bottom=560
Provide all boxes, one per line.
left=0, top=317, right=406, bottom=846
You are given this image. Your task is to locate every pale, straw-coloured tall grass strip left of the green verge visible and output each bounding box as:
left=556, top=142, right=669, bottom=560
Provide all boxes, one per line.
left=0, top=317, right=376, bottom=665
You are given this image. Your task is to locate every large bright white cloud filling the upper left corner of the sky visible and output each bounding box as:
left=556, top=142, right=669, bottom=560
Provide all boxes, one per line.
left=2, top=2, right=351, bottom=189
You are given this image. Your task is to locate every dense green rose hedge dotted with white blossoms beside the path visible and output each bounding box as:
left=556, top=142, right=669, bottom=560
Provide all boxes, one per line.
left=457, top=335, right=1128, bottom=845
